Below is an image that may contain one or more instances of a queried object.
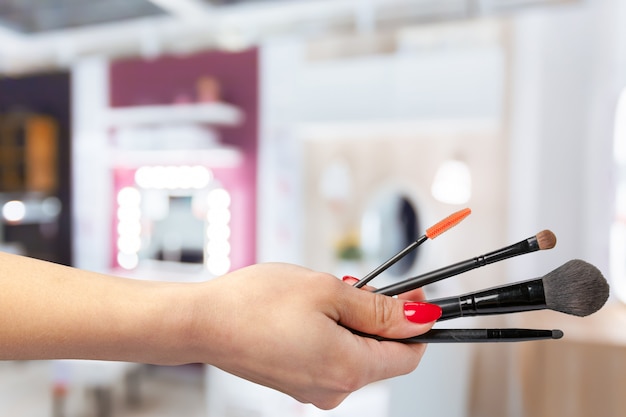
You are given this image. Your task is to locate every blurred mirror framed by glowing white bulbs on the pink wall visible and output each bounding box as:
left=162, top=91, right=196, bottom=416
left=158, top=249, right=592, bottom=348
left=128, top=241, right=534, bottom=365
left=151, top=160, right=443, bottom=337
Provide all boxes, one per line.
left=117, top=166, right=231, bottom=276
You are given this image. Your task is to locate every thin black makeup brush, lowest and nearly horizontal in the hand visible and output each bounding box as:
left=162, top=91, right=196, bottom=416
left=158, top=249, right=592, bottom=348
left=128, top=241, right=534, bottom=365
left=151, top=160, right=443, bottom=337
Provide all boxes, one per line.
left=363, top=329, right=563, bottom=343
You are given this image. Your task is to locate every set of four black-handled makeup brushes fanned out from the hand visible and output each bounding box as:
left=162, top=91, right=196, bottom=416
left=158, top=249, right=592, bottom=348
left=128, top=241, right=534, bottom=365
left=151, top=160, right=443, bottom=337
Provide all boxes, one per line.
left=354, top=209, right=609, bottom=343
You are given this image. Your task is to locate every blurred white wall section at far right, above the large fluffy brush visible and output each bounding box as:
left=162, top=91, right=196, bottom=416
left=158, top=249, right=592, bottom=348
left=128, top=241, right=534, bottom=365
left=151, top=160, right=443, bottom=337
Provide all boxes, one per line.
left=509, top=0, right=626, bottom=278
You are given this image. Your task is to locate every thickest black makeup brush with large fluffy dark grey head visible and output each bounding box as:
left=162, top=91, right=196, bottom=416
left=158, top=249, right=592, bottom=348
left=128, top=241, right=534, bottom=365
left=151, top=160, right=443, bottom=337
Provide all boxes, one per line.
left=428, top=259, right=609, bottom=320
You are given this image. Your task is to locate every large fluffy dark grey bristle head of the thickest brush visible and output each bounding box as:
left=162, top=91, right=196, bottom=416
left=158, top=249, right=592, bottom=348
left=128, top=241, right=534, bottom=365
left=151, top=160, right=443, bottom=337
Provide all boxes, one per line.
left=542, top=259, right=609, bottom=317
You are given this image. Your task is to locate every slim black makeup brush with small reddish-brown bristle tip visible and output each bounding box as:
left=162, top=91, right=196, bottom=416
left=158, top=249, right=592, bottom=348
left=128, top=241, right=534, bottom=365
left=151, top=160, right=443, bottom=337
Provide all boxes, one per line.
left=374, top=230, right=556, bottom=295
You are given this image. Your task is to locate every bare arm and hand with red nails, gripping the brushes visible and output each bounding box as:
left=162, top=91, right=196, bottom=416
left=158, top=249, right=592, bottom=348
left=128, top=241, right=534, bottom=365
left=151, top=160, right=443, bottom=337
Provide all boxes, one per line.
left=0, top=253, right=440, bottom=409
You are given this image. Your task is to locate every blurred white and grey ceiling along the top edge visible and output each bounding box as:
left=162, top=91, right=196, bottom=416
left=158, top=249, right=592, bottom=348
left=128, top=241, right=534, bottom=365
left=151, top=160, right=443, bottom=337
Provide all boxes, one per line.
left=0, top=0, right=582, bottom=75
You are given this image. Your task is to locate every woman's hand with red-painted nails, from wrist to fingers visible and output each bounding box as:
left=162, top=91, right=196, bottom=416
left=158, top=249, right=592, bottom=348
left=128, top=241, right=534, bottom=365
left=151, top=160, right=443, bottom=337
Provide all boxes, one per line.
left=194, top=264, right=441, bottom=409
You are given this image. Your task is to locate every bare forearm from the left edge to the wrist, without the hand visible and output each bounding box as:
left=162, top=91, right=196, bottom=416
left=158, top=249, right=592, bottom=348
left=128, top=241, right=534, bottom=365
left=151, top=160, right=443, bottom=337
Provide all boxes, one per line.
left=0, top=253, right=199, bottom=364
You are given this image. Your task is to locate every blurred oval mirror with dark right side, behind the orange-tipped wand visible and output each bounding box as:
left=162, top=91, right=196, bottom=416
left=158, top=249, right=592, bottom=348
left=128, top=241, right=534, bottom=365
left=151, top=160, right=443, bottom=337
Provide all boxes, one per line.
left=361, top=189, right=420, bottom=278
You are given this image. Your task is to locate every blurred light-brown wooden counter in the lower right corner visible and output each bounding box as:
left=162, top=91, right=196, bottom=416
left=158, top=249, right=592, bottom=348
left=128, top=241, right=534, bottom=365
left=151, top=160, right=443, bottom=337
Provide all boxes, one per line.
left=516, top=303, right=626, bottom=417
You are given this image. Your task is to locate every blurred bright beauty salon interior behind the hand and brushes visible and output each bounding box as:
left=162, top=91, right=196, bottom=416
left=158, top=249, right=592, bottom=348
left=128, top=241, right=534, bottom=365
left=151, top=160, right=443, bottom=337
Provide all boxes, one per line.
left=0, top=0, right=626, bottom=417
